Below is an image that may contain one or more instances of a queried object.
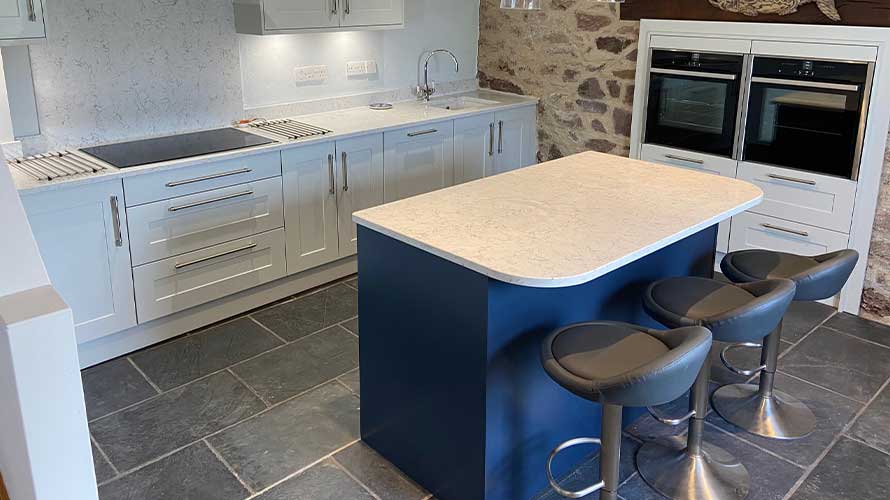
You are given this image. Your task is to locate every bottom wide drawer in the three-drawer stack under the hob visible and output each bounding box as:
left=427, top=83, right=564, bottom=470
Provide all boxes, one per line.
left=133, top=229, right=287, bottom=323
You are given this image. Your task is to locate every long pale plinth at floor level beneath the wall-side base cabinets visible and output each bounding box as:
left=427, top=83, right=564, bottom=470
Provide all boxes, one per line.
left=78, top=256, right=358, bottom=368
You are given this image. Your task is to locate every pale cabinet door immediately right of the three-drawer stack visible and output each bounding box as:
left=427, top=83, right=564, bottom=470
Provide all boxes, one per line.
left=281, top=142, right=340, bottom=274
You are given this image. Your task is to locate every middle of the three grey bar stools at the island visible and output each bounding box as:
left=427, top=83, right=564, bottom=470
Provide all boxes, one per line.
left=637, top=277, right=795, bottom=500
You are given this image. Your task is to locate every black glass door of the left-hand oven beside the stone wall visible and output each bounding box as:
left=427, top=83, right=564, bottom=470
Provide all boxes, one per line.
left=645, top=70, right=740, bottom=157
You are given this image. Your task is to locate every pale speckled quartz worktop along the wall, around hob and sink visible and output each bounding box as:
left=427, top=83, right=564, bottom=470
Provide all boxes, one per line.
left=9, top=90, right=538, bottom=194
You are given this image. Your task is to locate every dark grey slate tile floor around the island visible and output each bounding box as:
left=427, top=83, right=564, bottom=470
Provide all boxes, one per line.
left=83, top=279, right=890, bottom=500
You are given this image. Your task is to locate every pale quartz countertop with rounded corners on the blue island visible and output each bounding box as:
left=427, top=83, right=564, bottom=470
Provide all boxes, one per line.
left=353, top=152, right=763, bottom=288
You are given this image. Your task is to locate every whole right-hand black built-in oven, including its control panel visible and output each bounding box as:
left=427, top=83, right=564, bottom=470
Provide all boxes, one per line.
left=741, top=56, right=874, bottom=180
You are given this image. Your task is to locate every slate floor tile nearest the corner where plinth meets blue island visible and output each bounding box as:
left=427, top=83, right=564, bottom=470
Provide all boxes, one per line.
left=253, top=283, right=358, bottom=341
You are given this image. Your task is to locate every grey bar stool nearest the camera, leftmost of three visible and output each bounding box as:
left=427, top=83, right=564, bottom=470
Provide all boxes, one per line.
left=541, top=321, right=711, bottom=500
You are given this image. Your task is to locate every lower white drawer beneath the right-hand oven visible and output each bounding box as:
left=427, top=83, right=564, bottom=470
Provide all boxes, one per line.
left=729, top=212, right=849, bottom=255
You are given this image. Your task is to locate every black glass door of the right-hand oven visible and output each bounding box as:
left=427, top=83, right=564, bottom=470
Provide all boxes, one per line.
left=743, top=78, right=864, bottom=179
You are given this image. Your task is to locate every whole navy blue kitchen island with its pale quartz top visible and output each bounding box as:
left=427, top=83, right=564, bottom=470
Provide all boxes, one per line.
left=354, top=152, right=762, bottom=500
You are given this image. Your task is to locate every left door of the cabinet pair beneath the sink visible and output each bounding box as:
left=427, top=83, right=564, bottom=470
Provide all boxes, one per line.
left=454, top=113, right=496, bottom=184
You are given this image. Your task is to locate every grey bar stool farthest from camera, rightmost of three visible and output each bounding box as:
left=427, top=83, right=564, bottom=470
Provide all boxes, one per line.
left=711, top=250, right=859, bottom=439
